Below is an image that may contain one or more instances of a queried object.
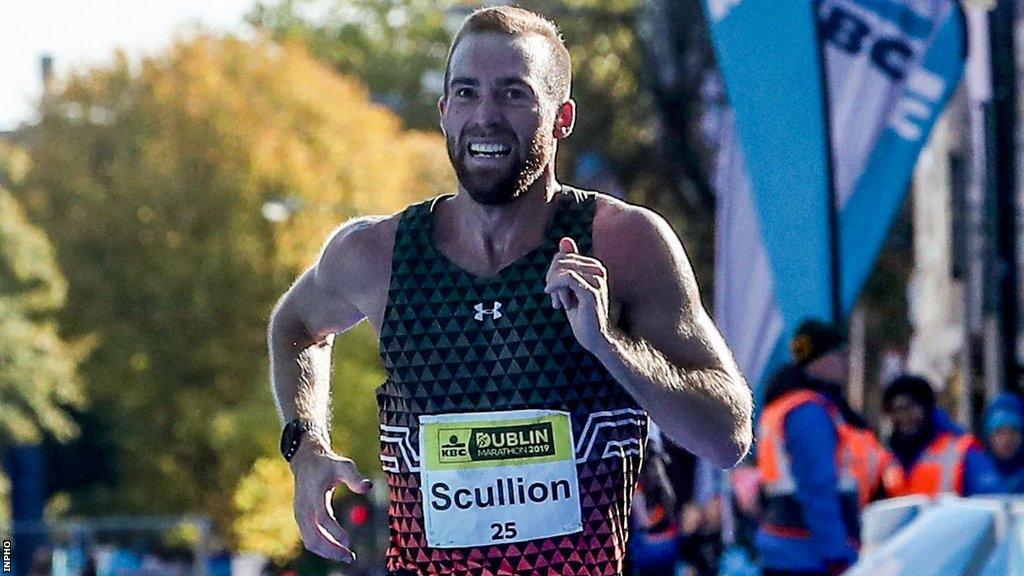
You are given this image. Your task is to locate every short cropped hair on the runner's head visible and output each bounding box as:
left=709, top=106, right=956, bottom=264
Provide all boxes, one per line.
left=444, top=6, right=572, bottom=104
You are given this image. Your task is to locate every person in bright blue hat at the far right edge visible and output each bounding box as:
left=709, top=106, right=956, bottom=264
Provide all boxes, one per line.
left=984, top=392, right=1024, bottom=487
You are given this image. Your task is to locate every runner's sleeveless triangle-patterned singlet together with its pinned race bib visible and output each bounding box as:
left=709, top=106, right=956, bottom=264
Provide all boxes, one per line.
left=377, top=189, right=647, bottom=576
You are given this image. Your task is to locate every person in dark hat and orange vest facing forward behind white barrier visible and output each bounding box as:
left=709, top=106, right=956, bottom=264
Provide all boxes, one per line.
left=882, top=374, right=999, bottom=496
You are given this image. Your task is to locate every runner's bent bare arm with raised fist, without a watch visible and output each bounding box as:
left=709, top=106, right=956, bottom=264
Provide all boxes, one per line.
left=547, top=206, right=753, bottom=467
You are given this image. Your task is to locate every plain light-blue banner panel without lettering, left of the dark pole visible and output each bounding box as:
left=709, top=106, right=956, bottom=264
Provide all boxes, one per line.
left=707, top=0, right=831, bottom=327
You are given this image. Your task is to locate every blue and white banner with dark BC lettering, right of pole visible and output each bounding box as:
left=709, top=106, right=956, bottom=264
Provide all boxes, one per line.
left=821, top=0, right=966, bottom=316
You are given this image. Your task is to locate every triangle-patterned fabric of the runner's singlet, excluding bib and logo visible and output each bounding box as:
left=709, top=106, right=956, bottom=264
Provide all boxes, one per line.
left=377, top=189, right=647, bottom=576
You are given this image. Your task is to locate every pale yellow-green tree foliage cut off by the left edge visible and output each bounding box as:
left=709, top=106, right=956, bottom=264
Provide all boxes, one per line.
left=0, top=145, right=83, bottom=447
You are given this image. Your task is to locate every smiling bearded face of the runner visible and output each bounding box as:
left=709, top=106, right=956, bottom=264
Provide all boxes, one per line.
left=440, top=33, right=557, bottom=205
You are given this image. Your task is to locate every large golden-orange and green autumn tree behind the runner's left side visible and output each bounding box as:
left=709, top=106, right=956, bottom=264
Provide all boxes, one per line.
left=16, top=35, right=453, bottom=545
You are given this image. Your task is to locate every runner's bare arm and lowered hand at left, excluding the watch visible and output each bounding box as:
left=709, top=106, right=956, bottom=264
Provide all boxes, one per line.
left=268, top=218, right=378, bottom=562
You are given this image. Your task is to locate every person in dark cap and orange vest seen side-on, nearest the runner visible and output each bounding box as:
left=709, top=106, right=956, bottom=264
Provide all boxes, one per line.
left=755, top=320, right=888, bottom=575
